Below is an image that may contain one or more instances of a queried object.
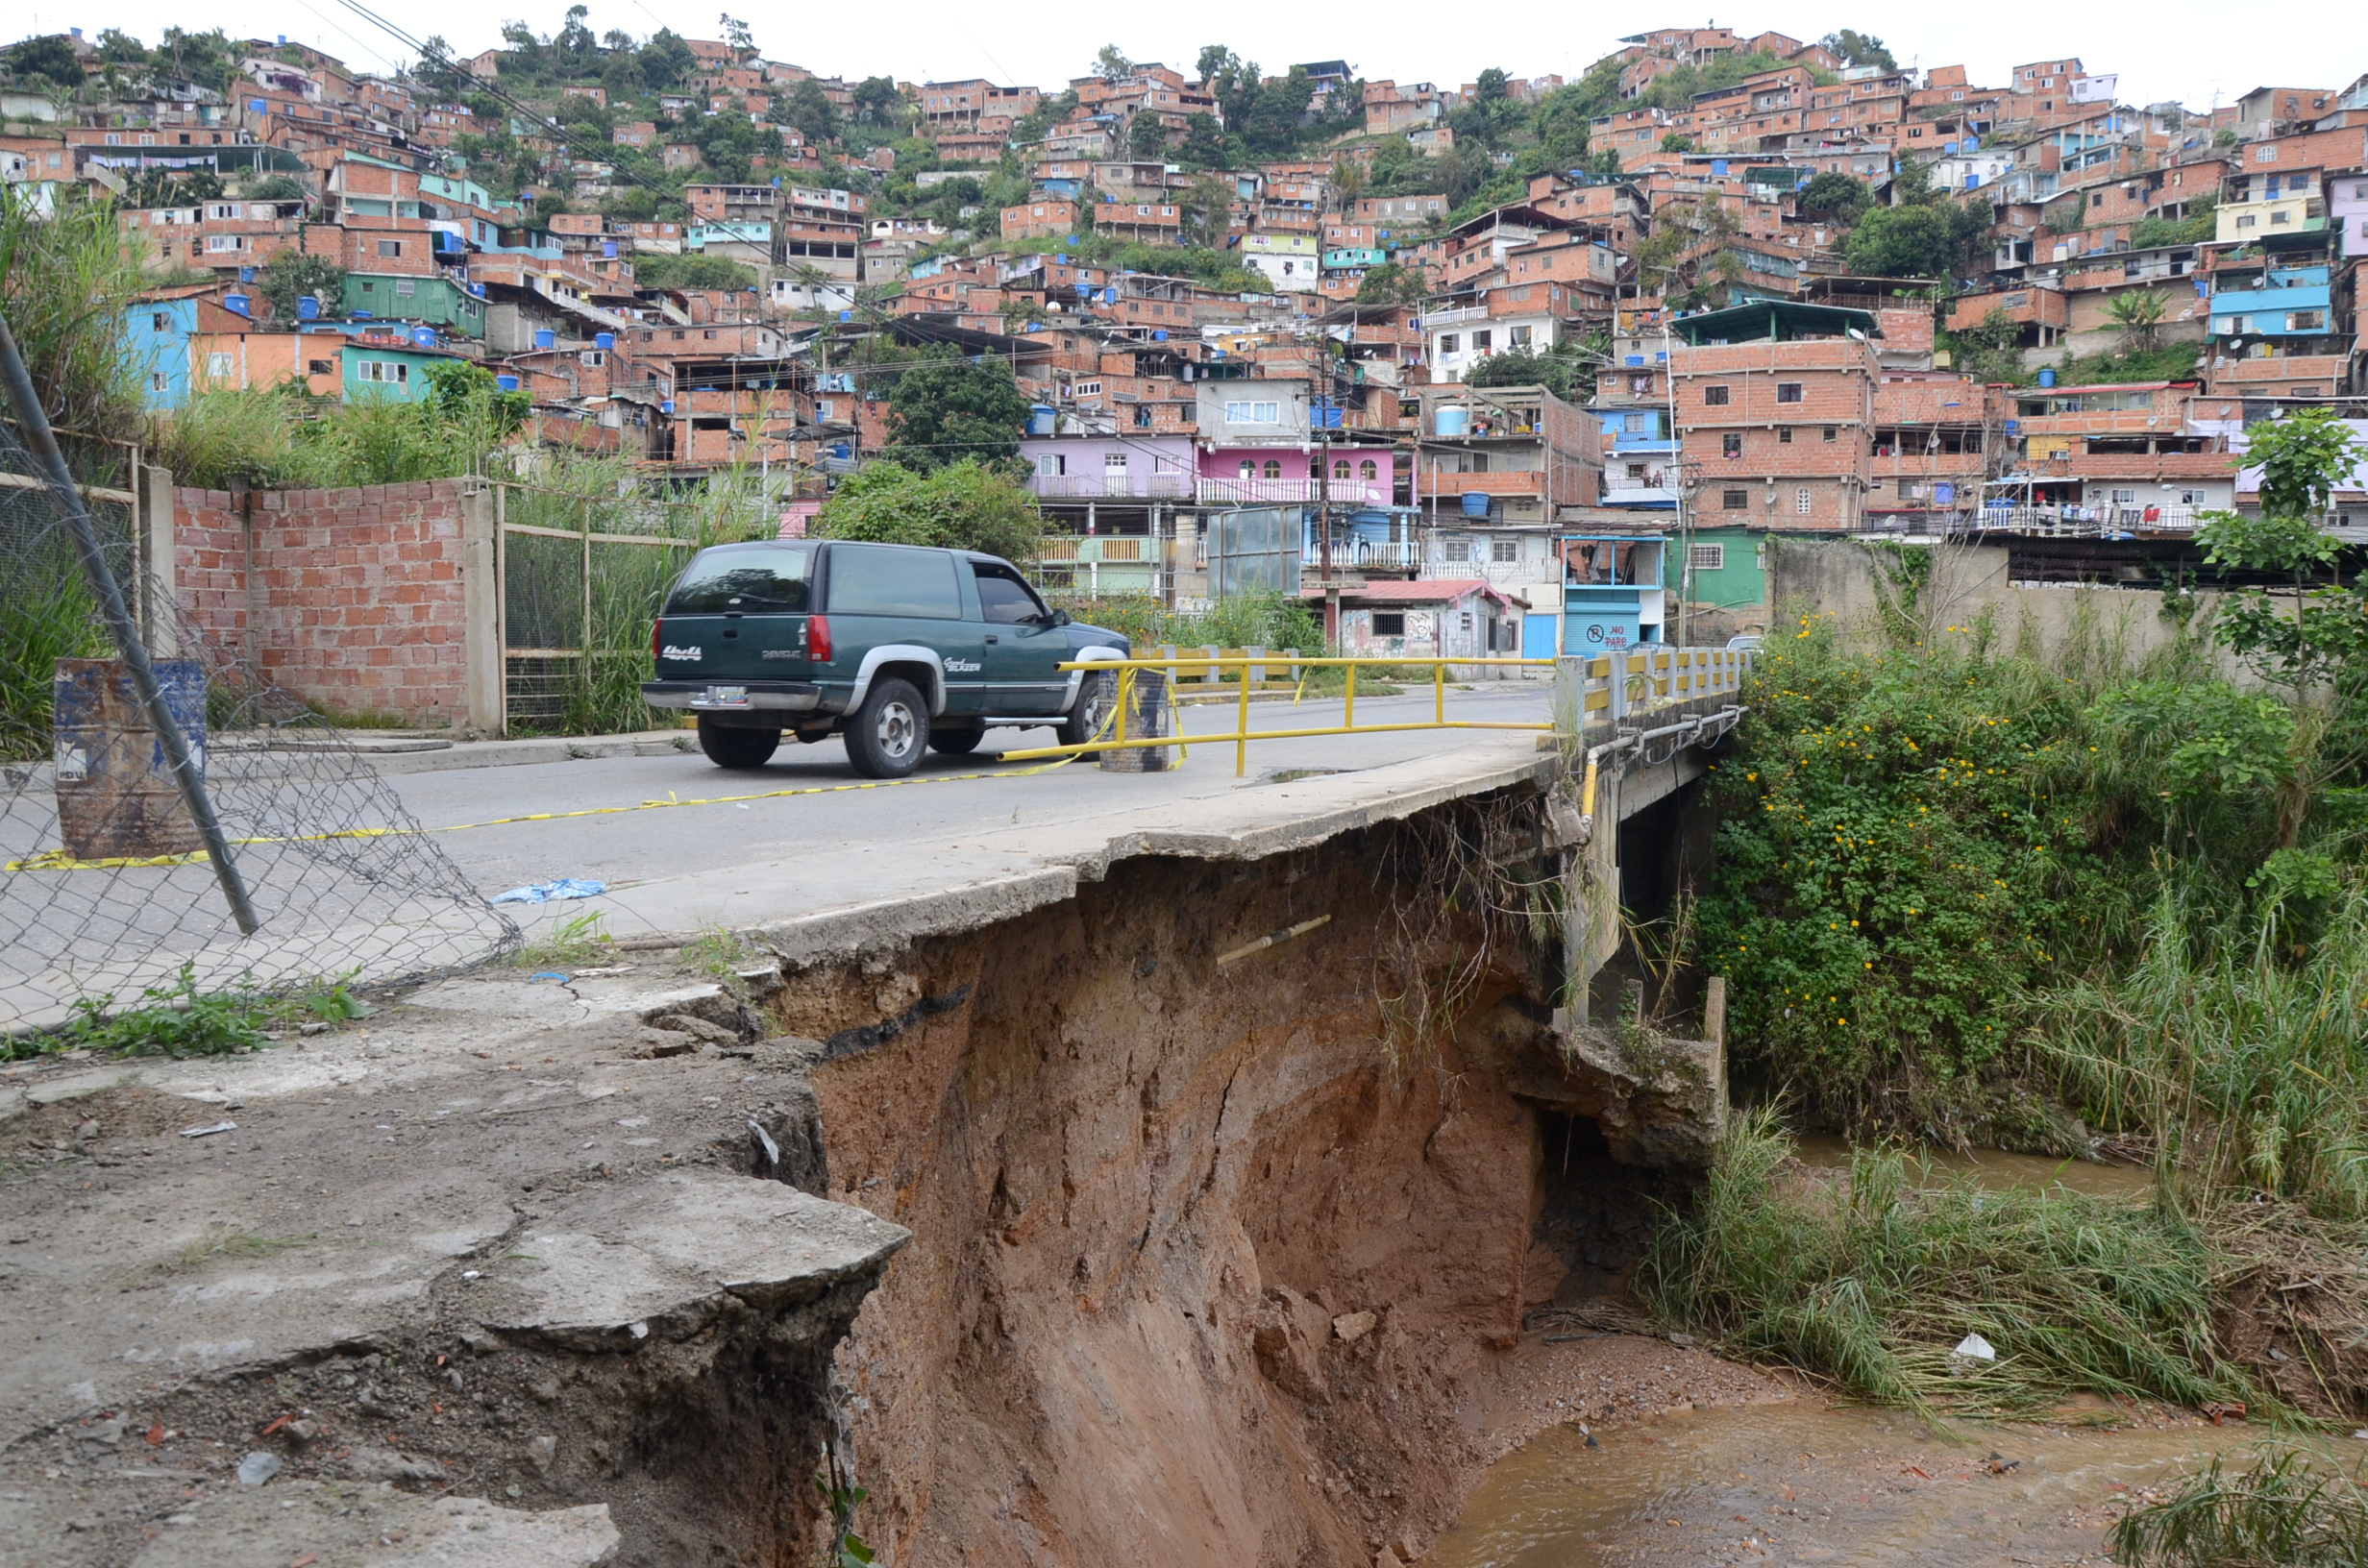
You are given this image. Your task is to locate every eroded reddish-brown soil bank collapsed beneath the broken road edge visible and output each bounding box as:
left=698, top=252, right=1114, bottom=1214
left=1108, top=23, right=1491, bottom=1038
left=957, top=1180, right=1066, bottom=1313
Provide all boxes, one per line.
left=779, top=796, right=1733, bottom=1568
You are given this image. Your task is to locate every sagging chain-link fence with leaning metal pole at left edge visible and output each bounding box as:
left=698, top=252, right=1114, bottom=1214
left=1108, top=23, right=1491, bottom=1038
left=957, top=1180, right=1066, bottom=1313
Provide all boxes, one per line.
left=0, top=407, right=519, bottom=1030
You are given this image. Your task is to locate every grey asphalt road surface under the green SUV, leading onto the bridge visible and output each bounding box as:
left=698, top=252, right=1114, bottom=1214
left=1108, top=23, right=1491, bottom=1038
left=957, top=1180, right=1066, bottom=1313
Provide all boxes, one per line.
left=388, top=682, right=1551, bottom=907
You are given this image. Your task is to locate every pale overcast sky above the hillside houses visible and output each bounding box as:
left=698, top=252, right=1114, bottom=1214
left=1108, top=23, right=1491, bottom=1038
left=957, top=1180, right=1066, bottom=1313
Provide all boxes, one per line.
left=33, top=0, right=2368, bottom=109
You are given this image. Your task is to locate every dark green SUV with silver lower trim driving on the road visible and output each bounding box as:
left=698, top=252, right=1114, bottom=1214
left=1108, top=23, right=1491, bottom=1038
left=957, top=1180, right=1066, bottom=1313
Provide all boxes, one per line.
left=642, top=540, right=1129, bottom=779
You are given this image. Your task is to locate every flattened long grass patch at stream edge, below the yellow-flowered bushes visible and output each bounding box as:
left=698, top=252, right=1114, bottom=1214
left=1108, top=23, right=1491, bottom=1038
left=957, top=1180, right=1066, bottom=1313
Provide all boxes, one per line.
left=1639, top=1111, right=2250, bottom=1414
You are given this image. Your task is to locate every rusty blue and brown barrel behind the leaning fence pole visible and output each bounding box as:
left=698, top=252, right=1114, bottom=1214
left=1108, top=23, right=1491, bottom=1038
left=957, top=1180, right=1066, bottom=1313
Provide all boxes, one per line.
left=50, top=658, right=206, bottom=860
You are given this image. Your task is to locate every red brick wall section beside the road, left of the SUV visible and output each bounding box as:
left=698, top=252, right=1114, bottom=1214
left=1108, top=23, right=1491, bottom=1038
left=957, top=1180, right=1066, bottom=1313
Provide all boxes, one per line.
left=173, top=478, right=469, bottom=724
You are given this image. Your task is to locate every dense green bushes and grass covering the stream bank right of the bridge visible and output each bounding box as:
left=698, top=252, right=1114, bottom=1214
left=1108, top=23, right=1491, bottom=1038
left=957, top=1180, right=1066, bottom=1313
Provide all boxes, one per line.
left=1648, top=412, right=2368, bottom=1421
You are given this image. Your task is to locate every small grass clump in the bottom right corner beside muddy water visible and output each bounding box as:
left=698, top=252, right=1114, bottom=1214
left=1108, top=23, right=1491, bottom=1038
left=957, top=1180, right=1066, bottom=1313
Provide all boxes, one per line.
left=2112, top=1442, right=2368, bottom=1568
